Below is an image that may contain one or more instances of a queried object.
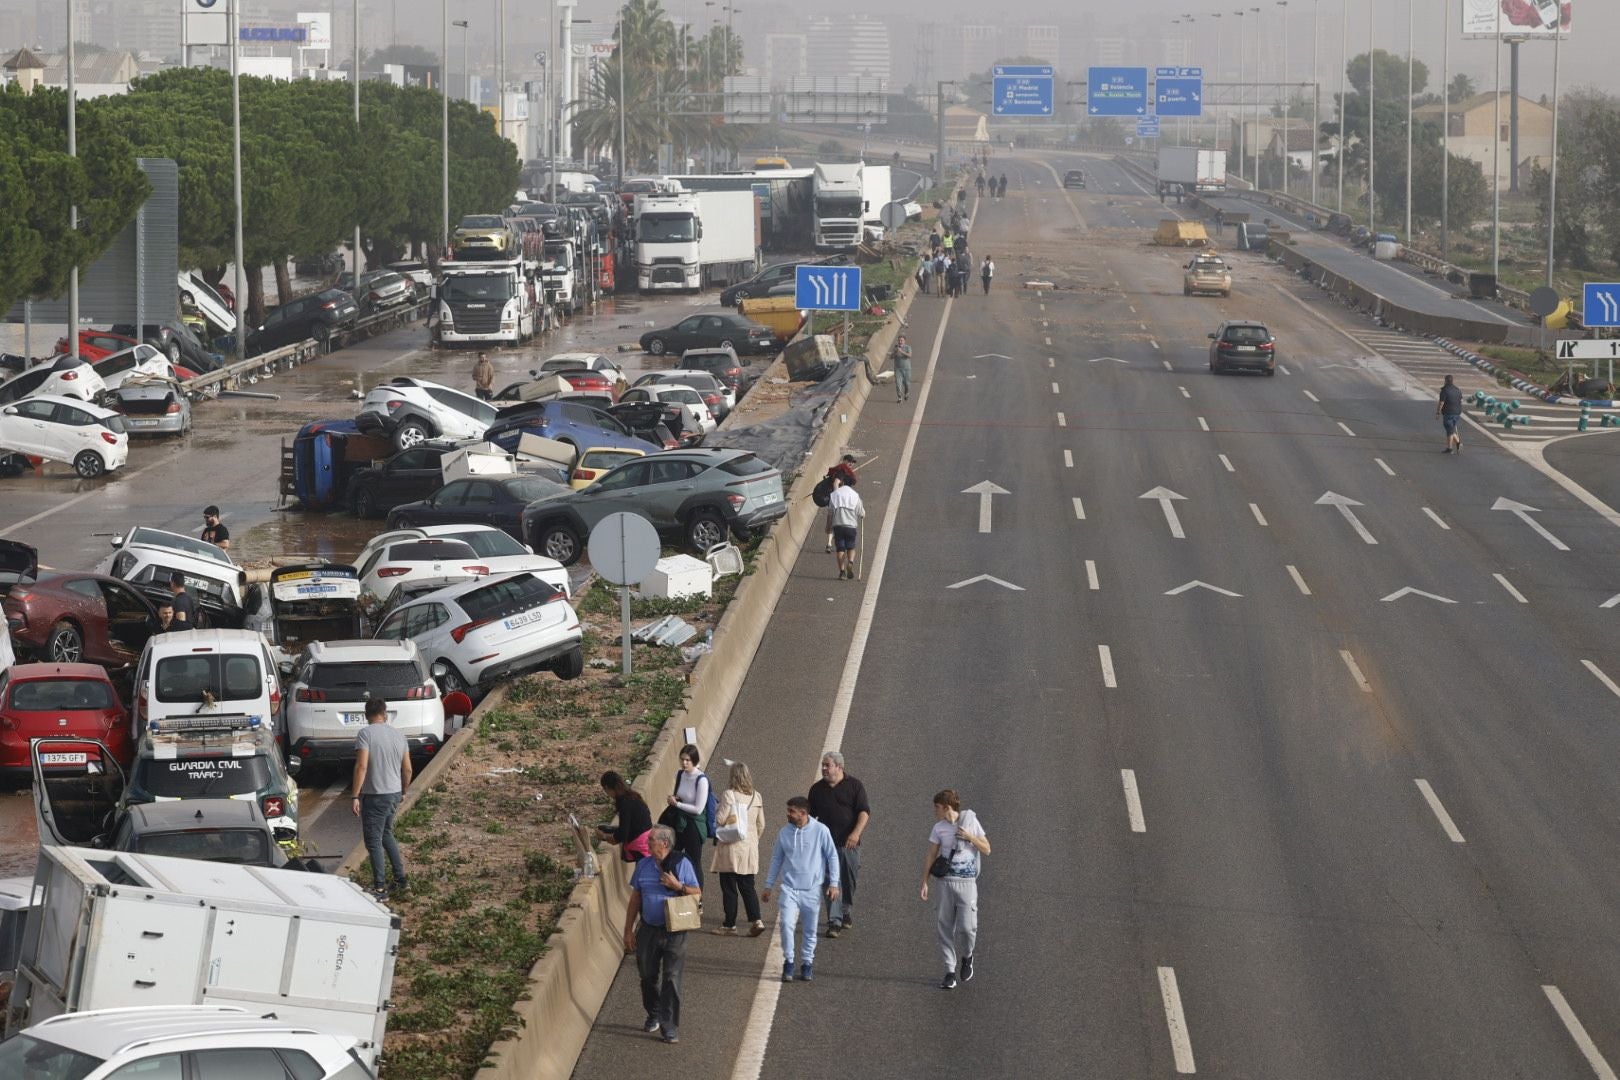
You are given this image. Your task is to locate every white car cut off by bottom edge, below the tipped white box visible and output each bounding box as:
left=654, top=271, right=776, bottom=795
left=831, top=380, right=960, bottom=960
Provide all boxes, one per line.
left=0, top=1006, right=374, bottom=1080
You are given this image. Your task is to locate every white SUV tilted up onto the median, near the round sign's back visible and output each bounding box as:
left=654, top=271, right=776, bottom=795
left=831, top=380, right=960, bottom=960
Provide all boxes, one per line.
left=374, top=573, right=585, bottom=693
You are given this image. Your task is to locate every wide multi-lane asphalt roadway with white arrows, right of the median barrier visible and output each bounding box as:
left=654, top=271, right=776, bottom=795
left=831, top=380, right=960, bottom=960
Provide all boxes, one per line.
left=575, top=159, right=1620, bottom=1080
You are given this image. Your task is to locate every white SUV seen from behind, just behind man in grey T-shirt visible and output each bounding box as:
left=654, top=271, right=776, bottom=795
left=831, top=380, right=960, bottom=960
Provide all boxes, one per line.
left=282, top=640, right=444, bottom=761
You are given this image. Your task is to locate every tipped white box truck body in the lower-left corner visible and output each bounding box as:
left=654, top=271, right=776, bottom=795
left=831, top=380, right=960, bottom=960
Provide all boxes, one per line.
left=5, top=845, right=400, bottom=1064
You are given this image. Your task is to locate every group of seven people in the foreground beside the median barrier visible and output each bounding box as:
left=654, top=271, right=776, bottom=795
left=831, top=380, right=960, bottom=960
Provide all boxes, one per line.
left=598, top=745, right=990, bottom=1043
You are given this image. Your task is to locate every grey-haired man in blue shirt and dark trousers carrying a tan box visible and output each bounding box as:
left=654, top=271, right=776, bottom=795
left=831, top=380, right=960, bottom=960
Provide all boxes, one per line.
left=624, top=826, right=703, bottom=1043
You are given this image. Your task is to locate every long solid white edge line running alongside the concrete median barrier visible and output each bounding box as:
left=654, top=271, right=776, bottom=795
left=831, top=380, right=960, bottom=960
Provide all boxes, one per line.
left=731, top=291, right=953, bottom=1080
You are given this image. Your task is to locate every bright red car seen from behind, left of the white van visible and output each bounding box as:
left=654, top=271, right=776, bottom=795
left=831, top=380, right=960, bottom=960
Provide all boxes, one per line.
left=0, top=664, right=134, bottom=780
